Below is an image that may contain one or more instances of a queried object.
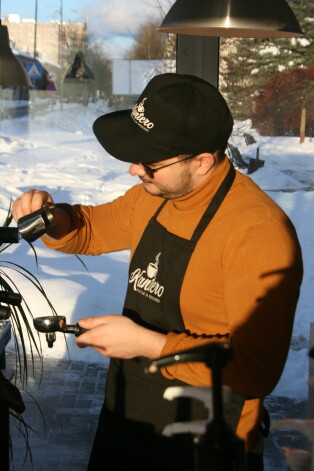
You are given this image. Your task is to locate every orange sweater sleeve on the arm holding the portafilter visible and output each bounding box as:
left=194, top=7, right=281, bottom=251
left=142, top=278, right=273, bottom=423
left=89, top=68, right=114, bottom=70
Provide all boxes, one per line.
left=162, top=221, right=302, bottom=396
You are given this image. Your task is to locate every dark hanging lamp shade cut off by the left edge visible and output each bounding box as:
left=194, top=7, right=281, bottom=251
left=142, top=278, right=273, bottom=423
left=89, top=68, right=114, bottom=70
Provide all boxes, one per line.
left=0, top=24, right=33, bottom=87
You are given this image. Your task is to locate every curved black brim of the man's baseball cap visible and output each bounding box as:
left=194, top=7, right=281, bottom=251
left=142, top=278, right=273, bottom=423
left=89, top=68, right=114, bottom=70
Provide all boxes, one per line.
left=93, top=109, right=176, bottom=163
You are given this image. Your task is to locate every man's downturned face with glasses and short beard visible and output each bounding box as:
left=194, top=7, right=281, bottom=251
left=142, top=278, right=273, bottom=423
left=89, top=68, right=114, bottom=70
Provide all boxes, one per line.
left=129, top=157, right=197, bottom=199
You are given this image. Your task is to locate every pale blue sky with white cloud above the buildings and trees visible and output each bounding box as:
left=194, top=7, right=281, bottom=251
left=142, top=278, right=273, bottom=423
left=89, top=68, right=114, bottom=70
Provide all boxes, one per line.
left=0, top=0, right=174, bottom=58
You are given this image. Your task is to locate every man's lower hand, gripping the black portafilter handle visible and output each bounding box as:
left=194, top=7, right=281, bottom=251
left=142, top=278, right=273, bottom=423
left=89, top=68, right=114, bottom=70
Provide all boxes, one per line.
left=76, top=315, right=166, bottom=359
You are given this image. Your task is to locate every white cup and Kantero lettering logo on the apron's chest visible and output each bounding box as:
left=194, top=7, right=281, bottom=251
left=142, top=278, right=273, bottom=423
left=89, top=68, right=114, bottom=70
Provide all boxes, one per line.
left=129, top=252, right=165, bottom=303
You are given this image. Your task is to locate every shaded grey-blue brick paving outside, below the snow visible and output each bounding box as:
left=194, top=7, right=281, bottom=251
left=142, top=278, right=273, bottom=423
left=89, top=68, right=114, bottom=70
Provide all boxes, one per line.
left=7, top=353, right=306, bottom=471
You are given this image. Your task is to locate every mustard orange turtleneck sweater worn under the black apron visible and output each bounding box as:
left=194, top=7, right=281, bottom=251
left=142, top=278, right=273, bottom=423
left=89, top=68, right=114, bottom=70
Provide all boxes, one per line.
left=44, top=159, right=302, bottom=450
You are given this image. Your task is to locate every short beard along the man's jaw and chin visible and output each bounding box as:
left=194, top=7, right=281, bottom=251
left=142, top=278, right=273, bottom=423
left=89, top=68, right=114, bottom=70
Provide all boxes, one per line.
left=140, top=165, right=195, bottom=200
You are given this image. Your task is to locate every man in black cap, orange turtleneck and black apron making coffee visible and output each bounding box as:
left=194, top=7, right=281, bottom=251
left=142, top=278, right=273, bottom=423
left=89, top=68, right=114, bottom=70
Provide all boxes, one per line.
left=12, top=74, right=302, bottom=471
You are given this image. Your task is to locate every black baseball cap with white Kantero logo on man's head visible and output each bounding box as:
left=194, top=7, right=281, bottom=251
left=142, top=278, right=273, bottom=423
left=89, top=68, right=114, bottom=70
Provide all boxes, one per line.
left=93, top=73, right=233, bottom=163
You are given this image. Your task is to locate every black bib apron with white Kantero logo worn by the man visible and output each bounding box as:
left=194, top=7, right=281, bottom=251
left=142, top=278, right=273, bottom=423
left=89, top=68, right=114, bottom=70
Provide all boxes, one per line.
left=88, top=164, right=235, bottom=471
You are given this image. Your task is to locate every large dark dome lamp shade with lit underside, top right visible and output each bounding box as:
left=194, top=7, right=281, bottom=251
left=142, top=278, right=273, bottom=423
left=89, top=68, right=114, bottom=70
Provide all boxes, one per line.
left=158, top=0, right=303, bottom=38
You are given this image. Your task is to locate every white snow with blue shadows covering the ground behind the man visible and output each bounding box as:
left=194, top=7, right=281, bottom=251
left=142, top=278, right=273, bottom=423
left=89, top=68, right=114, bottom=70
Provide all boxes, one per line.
left=0, top=102, right=314, bottom=400
